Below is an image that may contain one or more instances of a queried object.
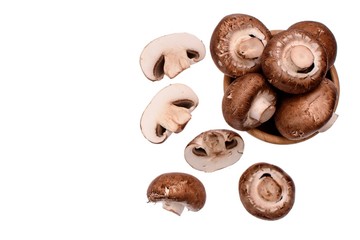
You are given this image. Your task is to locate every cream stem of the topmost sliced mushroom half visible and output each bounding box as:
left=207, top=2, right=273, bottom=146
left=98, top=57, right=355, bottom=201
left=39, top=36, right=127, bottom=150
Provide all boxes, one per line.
left=164, top=49, right=192, bottom=78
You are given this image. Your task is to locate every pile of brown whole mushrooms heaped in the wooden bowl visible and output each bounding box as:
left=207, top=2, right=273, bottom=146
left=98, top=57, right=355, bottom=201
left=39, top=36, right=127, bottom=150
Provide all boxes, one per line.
left=214, top=14, right=339, bottom=143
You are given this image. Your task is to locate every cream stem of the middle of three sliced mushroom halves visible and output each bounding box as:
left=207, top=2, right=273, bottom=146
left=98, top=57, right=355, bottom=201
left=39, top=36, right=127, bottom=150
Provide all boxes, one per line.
left=159, top=105, right=191, bottom=133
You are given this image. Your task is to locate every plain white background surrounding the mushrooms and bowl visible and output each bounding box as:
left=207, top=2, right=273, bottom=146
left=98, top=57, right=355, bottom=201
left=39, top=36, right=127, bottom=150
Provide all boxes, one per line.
left=0, top=0, right=360, bottom=240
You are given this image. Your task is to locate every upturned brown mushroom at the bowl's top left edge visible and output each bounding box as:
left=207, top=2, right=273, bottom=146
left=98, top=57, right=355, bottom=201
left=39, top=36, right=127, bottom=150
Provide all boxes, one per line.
left=210, top=14, right=271, bottom=77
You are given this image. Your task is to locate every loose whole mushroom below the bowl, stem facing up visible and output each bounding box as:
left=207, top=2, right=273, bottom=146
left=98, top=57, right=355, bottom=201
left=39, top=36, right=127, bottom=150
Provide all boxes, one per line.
left=239, top=162, right=295, bottom=220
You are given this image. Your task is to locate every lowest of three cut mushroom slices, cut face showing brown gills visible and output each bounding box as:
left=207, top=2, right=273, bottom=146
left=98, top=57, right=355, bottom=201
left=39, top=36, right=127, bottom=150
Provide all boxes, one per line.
left=184, top=129, right=244, bottom=172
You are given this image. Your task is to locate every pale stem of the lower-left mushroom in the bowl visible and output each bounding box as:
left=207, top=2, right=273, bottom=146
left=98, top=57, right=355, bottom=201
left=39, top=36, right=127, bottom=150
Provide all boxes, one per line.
left=249, top=94, right=276, bottom=123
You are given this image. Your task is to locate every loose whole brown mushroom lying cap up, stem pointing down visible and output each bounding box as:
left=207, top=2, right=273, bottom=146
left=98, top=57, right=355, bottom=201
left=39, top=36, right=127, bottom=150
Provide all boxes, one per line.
left=147, top=172, right=206, bottom=216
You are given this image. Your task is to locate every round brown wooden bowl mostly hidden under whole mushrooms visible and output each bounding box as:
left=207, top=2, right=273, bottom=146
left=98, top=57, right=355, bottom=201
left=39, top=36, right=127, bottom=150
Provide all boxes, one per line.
left=224, top=66, right=340, bottom=144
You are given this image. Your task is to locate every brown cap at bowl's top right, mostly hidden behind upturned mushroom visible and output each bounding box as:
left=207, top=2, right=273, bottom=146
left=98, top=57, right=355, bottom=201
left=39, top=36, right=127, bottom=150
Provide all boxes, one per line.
left=289, top=21, right=337, bottom=68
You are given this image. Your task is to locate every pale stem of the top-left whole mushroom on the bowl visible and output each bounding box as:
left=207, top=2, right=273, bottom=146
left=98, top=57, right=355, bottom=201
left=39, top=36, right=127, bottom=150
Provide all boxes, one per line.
left=237, top=37, right=264, bottom=59
